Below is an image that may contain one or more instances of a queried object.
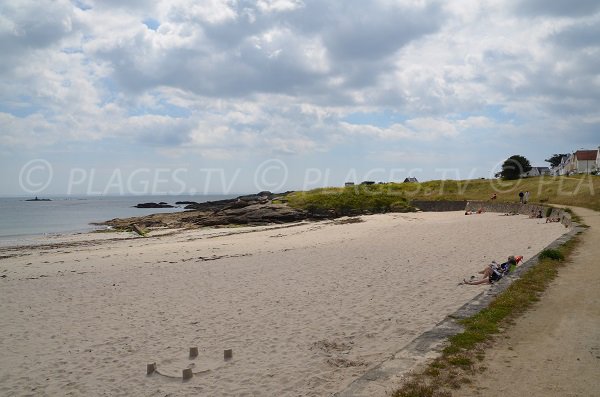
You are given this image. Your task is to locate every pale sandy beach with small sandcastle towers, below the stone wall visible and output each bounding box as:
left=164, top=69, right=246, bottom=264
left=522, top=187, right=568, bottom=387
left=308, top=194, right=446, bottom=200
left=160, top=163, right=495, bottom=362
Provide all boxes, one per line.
left=0, top=212, right=567, bottom=396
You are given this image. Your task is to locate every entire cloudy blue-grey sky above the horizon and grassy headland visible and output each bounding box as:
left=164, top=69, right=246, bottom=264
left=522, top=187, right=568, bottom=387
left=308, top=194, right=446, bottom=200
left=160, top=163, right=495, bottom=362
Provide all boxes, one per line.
left=0, top=0, right=600, bottom=196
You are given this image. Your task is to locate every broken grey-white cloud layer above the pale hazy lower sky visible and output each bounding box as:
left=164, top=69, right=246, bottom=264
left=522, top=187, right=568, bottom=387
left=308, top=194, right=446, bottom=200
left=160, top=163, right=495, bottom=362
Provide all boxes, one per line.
left=0, top=0, right=600, bottom=176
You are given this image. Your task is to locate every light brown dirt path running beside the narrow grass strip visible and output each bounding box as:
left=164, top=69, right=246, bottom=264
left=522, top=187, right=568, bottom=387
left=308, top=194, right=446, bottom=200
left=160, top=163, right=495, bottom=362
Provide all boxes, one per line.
left=460, top=208, right=600, bottom=397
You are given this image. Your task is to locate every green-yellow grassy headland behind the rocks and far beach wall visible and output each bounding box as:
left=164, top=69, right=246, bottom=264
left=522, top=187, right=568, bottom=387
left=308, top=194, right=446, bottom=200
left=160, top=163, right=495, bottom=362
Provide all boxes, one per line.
left=285, top=175, right=600, bottom=214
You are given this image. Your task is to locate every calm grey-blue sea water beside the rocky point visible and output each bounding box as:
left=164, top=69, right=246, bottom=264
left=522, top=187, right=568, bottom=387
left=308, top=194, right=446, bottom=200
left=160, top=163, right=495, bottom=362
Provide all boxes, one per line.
left=0, top=195, right=238, bottom=245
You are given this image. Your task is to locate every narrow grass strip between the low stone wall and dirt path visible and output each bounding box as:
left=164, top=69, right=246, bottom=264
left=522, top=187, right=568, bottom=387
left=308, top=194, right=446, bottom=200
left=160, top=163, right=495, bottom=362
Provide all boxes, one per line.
left=393, top=237, right=579, bottom=397
